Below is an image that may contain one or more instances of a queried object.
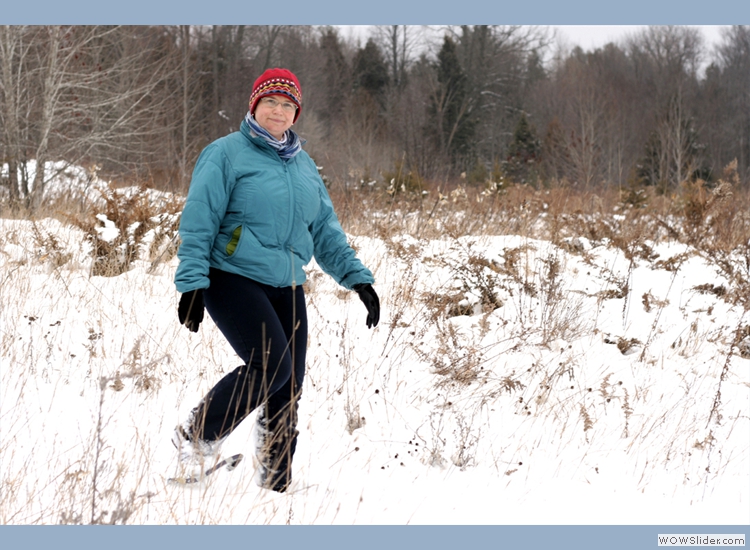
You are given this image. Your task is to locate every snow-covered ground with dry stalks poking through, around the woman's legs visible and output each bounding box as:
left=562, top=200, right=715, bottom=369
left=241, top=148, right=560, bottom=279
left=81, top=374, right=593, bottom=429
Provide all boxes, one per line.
left=0, top=199, right=750, bottom=525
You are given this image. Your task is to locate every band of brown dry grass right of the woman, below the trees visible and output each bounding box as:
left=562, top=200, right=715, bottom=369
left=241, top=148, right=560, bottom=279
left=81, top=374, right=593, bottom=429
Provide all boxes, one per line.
left=330, top=163, right=750, bottom=266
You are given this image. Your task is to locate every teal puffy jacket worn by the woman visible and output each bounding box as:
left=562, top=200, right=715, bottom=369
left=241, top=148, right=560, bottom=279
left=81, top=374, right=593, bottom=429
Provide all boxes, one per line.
left=175, top=120, right=374, bottom=293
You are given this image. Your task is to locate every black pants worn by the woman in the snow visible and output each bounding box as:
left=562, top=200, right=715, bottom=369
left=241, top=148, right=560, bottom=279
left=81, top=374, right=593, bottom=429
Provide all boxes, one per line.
left=193, top=269, right=307, bottom=488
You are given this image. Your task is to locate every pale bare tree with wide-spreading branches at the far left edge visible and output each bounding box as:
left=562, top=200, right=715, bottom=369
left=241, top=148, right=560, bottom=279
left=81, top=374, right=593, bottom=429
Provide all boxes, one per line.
left=0, top=25, right=181, bottom=207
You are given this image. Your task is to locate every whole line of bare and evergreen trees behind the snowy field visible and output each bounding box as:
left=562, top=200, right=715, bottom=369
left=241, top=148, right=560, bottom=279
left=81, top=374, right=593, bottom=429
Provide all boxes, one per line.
left=0, top=25, right=750, bottom=210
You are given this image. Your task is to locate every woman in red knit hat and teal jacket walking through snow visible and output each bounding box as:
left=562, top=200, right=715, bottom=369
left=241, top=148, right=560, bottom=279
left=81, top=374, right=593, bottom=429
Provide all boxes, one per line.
left=172, top=69, right=380, bottom=492
